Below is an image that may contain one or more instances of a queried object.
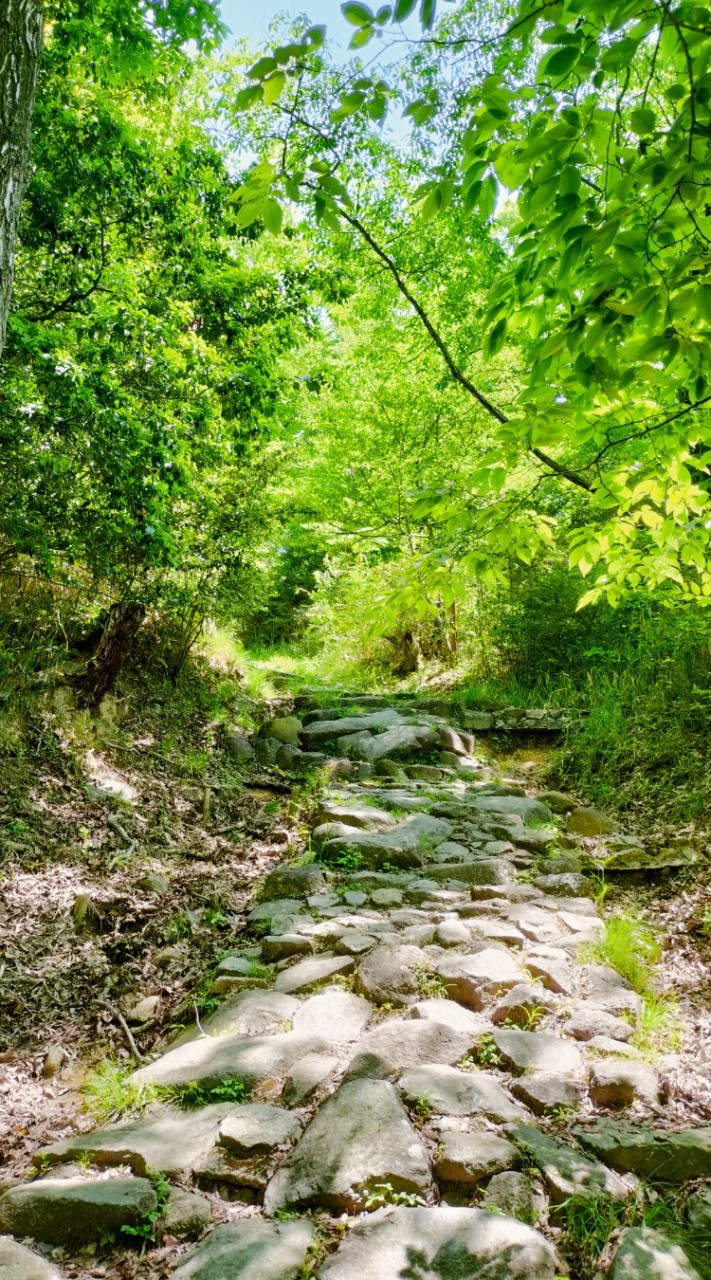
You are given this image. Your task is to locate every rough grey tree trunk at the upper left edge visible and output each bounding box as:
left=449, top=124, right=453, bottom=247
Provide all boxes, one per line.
left=0, top=0, right=44, bottom=358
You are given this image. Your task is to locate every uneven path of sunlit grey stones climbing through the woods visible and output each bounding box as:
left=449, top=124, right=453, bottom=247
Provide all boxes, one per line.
left=0, top=698, right=711, bottom=1280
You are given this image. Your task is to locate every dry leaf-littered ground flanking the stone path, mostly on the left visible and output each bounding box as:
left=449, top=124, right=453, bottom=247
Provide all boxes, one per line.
left=0, top=673, right=711, bottom=1280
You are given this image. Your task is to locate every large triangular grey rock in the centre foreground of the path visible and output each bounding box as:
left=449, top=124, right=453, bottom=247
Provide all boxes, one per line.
left=264, top=1080, right=432, bottom=1215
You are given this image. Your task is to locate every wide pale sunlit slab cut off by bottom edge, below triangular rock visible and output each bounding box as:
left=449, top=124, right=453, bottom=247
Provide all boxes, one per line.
left=318, top=1206, right=557, bottom=1280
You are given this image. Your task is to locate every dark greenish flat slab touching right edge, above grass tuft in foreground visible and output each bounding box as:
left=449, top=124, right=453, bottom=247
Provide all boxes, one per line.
left=573, top=1120, right=711, bottom=1184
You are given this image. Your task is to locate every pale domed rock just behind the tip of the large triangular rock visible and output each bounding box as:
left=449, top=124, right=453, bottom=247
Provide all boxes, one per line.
left=345, top=1018, right=475, bottom=1080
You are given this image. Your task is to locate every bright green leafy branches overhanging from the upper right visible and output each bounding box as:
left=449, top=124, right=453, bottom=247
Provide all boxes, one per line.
left=225, top=0, right=711, bottom=603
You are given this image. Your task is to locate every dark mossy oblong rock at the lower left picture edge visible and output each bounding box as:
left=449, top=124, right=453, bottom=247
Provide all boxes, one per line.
left=0, top=1178, right=158, bottom=1245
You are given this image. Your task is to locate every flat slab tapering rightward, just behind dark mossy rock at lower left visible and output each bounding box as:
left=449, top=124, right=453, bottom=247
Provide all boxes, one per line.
left=34, top=1102, right=238, bottom=1172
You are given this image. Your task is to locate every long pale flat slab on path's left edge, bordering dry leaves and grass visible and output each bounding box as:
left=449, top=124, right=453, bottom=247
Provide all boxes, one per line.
left=132, top=1032, right=329, bottom=1088
